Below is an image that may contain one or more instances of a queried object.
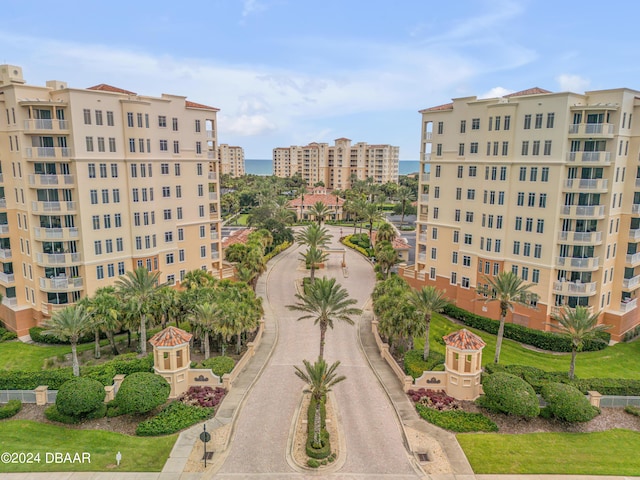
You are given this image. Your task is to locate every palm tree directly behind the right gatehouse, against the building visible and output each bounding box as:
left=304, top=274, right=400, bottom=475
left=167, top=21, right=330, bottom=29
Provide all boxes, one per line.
left=478, top=271, right=536, bottom=363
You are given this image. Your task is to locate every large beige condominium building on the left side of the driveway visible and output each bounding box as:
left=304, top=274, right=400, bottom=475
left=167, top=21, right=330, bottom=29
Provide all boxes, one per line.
left=0, top=65, right=221, bottom=335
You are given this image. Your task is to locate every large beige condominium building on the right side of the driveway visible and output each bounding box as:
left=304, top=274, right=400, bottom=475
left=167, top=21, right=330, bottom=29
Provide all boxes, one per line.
left=403, top=88, right=640, bottom=340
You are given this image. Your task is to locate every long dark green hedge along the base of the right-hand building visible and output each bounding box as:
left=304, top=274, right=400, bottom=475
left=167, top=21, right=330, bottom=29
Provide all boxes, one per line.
left=442, top=304, right=611, bottom=352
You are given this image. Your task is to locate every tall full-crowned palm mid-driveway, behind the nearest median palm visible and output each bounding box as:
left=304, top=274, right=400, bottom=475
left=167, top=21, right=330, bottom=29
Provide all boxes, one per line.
left=287, top=277, right=362, bottom=359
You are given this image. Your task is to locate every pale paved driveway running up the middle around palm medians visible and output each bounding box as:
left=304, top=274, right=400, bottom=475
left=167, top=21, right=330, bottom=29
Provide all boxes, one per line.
left=215, top=227, right=418, bottom=480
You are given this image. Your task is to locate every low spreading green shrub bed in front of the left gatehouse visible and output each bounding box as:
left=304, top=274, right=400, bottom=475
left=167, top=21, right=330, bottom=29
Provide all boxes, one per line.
left=136, top=401, right=215, bottom=437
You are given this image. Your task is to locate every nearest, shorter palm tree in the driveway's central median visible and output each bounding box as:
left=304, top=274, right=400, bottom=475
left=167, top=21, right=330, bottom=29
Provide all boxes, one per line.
left=294, top=358, right=347, bottom=448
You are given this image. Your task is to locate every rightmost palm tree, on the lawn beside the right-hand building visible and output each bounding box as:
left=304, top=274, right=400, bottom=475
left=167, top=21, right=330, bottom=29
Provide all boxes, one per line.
left=547, top=305, right=611, bottom=379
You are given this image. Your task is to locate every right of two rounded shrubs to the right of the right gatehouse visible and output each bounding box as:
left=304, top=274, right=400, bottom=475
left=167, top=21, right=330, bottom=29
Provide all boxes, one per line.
left=542, top=383, right=600, bottom=423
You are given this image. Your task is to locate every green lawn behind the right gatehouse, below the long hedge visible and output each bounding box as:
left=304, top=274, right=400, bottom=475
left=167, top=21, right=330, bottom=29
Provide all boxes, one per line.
left=415, top=315, right=640, bottom=379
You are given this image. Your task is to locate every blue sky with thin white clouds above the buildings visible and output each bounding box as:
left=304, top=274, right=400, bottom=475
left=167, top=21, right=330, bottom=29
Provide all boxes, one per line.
left=0, top=0, right=640, bottom=160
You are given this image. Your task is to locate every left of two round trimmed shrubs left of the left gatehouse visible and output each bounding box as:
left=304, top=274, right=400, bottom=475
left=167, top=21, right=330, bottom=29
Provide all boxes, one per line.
left=56, top=377, right=105, bottom=419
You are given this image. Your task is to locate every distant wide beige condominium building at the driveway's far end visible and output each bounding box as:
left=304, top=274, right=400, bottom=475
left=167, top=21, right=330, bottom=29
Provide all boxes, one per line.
left=273, top=138, right=400, bottom=189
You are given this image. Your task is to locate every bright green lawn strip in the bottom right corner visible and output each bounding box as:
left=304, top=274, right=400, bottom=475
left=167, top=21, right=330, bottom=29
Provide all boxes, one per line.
left=457, top=429, right=640, bottom=476
